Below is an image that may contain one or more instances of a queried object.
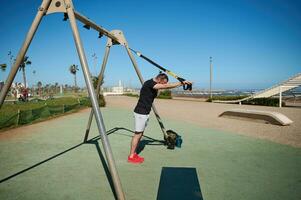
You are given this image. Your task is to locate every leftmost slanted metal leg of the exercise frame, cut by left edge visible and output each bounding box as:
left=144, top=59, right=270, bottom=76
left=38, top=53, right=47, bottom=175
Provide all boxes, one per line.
left=0, top=0, right=51, bottom=108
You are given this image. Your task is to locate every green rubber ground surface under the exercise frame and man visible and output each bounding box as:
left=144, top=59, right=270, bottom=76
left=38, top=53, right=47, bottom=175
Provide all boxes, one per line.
left=0, top=108, right=301, bottom=200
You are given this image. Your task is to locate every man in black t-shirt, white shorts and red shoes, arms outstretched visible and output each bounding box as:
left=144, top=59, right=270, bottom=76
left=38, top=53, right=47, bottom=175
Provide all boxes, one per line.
left=128, top=73, right=192, bottom=164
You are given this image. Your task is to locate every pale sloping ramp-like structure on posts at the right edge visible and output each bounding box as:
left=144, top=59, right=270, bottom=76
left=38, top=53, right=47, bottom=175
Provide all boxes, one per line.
left=213, top=73, right=301, bottom=107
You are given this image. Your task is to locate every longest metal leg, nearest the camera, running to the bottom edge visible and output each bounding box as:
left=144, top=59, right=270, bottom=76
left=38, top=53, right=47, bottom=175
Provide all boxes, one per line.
left=66, top=3, right=125, bottom=200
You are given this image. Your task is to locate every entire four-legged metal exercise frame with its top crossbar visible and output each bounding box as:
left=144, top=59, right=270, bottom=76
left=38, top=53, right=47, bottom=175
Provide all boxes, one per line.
left=0, top=0, right=189, bottom=200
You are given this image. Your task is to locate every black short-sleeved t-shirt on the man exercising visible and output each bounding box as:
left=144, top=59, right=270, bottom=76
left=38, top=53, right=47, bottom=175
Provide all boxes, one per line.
left=134, top=79, right=158, bottom=115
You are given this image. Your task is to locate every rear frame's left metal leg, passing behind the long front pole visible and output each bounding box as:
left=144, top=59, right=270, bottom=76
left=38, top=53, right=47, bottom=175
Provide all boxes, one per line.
left=84, top=45, right=111, bottom=142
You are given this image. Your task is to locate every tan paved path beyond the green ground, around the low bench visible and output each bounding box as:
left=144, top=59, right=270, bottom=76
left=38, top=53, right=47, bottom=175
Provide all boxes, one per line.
left=106, top=96, right=301, bottom=148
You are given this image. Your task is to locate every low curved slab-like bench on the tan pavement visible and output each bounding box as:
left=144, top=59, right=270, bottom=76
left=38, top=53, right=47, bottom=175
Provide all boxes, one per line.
left=219, top=109, right=293, bottom=126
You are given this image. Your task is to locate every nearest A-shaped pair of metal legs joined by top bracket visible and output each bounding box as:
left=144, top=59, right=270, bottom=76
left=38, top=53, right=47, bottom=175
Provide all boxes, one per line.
left=0, top=0, right=125, bottom=200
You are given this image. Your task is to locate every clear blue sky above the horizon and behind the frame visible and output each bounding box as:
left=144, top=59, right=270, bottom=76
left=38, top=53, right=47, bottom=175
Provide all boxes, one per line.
left=0, top=0, right=301, bottom=89
